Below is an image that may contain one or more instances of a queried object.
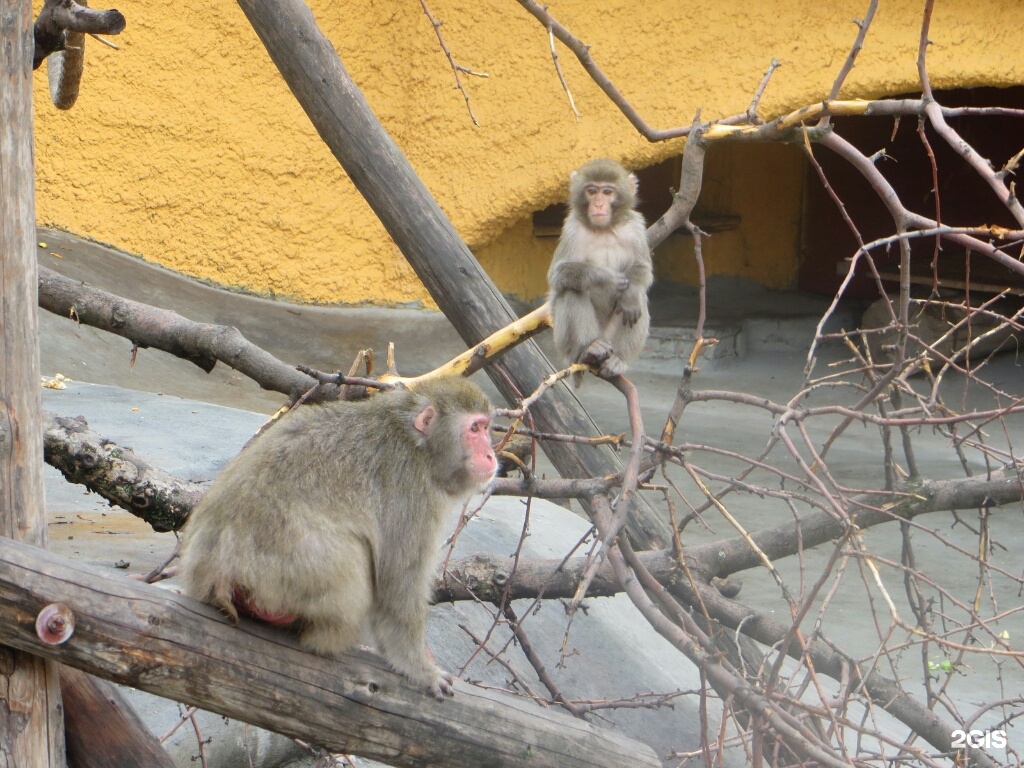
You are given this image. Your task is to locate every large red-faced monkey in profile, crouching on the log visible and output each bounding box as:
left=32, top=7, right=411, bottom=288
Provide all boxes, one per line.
left=181, top=378, right=497, bottom=698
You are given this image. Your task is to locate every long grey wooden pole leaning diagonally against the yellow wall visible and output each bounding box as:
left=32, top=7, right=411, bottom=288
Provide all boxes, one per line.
left=238, top=0, right=671, bottom=549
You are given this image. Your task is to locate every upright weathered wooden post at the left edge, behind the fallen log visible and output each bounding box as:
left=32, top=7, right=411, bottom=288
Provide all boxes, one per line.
left=0, top=0, right=65, bottom=768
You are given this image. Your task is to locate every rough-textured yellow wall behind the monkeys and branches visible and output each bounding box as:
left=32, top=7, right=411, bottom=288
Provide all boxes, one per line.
left=29, top=0, right=1024, bottom=303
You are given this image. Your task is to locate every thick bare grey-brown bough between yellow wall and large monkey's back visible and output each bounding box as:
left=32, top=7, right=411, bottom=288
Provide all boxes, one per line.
left=39, top=267, right=316, bottom=399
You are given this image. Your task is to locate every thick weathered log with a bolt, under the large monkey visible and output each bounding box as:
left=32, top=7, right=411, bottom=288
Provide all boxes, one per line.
left=0, top=540, right=660, bottom=768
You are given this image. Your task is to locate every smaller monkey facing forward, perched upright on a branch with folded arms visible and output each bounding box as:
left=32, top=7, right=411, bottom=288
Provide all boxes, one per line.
left=548, top=159, right=654, bottom=386
